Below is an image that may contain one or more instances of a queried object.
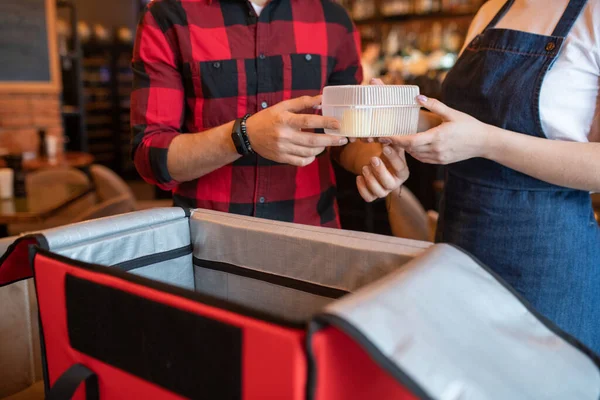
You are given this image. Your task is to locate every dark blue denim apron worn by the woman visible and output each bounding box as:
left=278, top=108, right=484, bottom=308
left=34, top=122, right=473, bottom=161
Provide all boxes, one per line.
left=437, top=0, right=600, bottom=353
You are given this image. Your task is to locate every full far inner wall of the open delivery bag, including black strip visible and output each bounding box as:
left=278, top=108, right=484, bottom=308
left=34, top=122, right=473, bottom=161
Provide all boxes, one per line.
left=190, top=210, right=431, bottom=321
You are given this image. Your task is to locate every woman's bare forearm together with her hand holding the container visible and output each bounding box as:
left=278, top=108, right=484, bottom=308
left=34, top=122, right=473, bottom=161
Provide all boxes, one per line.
left=386, top=96, right=600, bottom=192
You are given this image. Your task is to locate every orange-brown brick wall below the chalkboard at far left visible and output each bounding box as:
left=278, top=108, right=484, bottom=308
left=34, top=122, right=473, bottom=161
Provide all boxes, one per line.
left=0, top=92, right=63, bottom=153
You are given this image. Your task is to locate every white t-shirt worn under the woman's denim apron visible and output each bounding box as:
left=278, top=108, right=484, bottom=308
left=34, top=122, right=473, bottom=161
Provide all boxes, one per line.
left=465, top=0, right=600, bottom=142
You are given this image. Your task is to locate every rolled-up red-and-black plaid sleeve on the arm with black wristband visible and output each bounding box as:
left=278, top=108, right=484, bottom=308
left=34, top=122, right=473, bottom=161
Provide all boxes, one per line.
left=131, top=5, right=184, bottom=190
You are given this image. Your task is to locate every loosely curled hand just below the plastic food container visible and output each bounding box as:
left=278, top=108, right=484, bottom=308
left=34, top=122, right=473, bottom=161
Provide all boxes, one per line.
left=356, top=146, right=409, bottom=202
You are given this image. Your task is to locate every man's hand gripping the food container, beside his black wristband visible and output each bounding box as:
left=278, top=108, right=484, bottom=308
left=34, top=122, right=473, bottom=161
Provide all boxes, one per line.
left=246, top=96, right=348, bottom=167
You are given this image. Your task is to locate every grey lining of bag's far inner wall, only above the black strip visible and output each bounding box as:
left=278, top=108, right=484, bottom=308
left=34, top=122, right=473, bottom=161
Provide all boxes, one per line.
left=190, top=210, right=431, bottom=292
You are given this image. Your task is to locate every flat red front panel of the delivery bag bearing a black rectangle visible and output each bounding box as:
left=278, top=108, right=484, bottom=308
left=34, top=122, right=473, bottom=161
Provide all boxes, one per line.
left=34, top=252, right=307, bottom=400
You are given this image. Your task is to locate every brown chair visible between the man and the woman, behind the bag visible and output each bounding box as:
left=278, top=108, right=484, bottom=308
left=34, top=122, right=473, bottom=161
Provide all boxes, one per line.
left=386, top=187, right=438, bottom=242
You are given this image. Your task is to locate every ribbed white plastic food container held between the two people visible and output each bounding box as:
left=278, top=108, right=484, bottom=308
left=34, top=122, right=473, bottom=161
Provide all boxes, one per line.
left=321, top=85, right=421, bottom=137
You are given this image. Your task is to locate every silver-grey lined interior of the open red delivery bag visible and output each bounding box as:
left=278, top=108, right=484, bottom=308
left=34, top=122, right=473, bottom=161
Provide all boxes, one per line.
left=51, top=211, right=426, bottom=323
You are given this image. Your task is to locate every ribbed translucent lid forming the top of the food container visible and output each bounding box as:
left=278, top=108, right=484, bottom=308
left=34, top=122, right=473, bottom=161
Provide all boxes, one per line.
left=323, top=85, right=419, bottom=106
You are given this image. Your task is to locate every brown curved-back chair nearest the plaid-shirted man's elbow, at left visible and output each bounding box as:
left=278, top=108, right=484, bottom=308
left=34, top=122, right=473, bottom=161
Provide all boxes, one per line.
left=90, top=164, right=173, bottom=210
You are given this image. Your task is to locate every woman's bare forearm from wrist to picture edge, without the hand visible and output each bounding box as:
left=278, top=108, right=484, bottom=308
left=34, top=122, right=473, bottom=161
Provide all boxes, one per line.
left=484, top=125, right=600, bottom=192
